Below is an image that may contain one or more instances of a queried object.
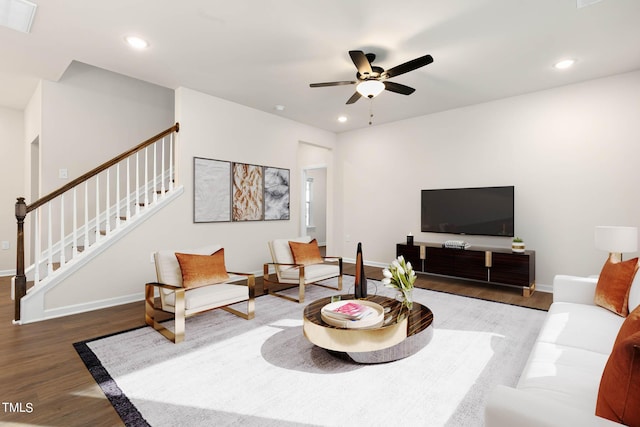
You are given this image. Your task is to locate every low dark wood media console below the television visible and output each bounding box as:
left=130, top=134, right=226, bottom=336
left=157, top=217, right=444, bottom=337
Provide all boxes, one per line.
left=396, top=242, right=536, bottom=297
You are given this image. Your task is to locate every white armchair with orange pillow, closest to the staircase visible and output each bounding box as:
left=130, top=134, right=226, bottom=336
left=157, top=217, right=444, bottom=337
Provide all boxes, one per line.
left=145, top=245, right=255, bottom=343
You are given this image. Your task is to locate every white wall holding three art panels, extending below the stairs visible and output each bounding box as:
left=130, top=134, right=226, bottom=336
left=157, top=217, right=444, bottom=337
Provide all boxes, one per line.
left=46, top=88, right=336, bottom=310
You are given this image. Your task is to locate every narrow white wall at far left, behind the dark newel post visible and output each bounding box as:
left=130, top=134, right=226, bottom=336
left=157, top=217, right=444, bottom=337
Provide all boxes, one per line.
left=0, top=107, right=25, bottom=273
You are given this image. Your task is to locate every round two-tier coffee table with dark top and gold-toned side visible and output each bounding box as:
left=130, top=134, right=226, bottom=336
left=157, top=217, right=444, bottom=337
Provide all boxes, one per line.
left=303, top=295, right=433, bottom=363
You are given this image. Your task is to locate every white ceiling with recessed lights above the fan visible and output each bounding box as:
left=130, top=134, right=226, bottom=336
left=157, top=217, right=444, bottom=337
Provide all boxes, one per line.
left=0, top=0, right=640, bottom=132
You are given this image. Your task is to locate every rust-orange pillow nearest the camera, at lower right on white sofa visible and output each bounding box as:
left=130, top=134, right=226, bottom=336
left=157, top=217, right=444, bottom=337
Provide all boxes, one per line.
left=596, top=332, right=640, bottom=426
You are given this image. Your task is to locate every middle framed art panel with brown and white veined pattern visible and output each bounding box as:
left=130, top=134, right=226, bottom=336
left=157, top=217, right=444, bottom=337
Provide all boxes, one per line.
left=231, top=163, right=264, bottom=221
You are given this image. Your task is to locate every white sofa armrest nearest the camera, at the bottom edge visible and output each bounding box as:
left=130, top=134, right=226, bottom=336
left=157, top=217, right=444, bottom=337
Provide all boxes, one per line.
left=484, top=385, right=622, bottom=427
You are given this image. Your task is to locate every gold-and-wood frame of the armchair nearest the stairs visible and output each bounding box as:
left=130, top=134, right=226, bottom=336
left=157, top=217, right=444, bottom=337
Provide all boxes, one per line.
left=144, top=272, right=256, bottom=344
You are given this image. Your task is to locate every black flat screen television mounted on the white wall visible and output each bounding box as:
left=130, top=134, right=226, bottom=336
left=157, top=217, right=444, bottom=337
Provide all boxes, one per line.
left=421, top=186, right=514, bottom=237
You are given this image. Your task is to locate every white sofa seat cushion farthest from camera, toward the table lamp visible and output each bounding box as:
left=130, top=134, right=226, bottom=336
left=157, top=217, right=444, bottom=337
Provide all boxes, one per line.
left=538, top=302, right=625, bottom=357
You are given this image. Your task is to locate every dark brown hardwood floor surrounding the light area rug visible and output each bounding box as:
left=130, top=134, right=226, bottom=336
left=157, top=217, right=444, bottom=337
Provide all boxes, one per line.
left=0, top=264, right=552, bottom=427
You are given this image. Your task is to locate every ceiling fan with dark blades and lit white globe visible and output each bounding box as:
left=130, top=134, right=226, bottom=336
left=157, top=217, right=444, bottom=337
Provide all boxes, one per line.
left=309, top=50, right=433, bottom=104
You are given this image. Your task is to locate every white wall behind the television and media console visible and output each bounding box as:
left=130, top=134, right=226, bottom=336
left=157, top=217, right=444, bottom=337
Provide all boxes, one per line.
left=336, top=72, right=640, bottom=285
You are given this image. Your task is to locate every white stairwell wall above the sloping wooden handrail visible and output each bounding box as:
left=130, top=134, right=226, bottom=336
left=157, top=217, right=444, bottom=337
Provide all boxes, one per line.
left=40, top=62, right=174, bottom=196
